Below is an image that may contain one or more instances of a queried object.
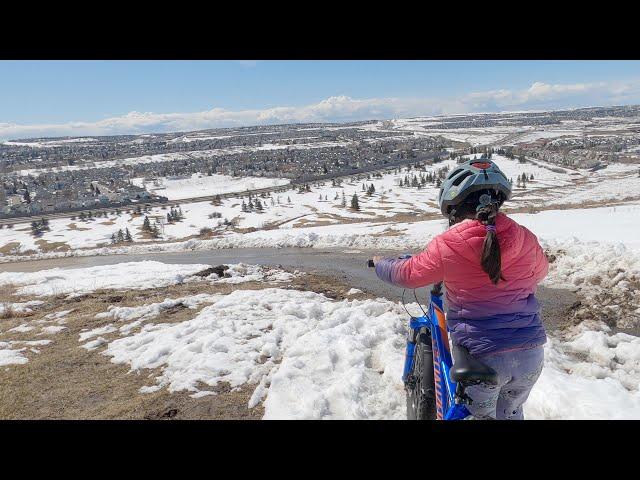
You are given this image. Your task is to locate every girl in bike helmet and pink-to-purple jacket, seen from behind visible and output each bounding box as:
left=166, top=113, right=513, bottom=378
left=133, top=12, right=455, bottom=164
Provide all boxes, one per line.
left=373, top=159, right=549, bottom=420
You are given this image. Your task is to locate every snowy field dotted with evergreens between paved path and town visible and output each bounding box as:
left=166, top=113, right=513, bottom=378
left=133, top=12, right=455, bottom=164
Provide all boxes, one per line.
left=0, top=155, right=640, bottom=262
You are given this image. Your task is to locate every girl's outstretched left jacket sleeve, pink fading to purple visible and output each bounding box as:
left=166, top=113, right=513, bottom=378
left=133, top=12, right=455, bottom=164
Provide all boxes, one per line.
left=376, top=239, right=444, bottom=288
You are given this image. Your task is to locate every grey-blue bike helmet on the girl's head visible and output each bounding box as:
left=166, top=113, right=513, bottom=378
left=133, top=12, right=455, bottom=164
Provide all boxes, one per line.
left=438, top=158, right=511, bottom=217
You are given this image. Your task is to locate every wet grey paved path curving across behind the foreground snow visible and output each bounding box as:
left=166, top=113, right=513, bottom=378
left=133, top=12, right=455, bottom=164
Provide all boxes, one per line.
left=0, top=248, right=577, bottom=331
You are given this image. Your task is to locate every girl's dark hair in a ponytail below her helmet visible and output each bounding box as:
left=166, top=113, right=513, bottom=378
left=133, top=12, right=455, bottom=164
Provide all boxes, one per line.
left=449, top=190, right=504, bottom=284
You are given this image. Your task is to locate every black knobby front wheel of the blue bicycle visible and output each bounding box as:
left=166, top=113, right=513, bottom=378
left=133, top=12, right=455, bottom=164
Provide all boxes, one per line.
left=407, top=333, right=436, bottom=420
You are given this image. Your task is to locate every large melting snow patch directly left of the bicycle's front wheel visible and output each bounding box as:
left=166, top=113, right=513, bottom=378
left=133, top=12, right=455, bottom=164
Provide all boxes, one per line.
left=104, top=289, right=404, bottom=418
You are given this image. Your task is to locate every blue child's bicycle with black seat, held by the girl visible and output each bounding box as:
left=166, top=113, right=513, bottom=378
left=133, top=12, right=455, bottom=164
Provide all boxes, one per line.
left=367, top=255, right=497, bottom=420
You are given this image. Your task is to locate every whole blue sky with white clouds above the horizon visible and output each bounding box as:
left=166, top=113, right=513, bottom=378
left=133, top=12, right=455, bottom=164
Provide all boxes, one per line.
left=0, top=60, right=640, bottom=140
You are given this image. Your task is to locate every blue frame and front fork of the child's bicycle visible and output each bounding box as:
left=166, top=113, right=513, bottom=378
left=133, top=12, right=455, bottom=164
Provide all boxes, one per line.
left=402, top=284, right=470, bottom=420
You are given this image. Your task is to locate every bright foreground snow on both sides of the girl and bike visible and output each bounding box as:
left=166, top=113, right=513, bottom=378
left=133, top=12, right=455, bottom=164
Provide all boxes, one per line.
left=85, top=288, right=640, bottom=419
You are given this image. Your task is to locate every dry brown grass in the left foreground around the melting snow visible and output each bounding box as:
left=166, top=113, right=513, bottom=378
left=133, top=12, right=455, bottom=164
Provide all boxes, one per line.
left=0, top=268, right=353, bottom=419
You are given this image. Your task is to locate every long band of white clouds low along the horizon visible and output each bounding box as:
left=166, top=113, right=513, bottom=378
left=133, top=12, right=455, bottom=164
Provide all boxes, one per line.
left=0, top=81, right=640, bottom=140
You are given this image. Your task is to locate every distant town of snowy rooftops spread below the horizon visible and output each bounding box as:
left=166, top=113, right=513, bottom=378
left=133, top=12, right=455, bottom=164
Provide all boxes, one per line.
left=0, top=106, right=640, bottom=218
